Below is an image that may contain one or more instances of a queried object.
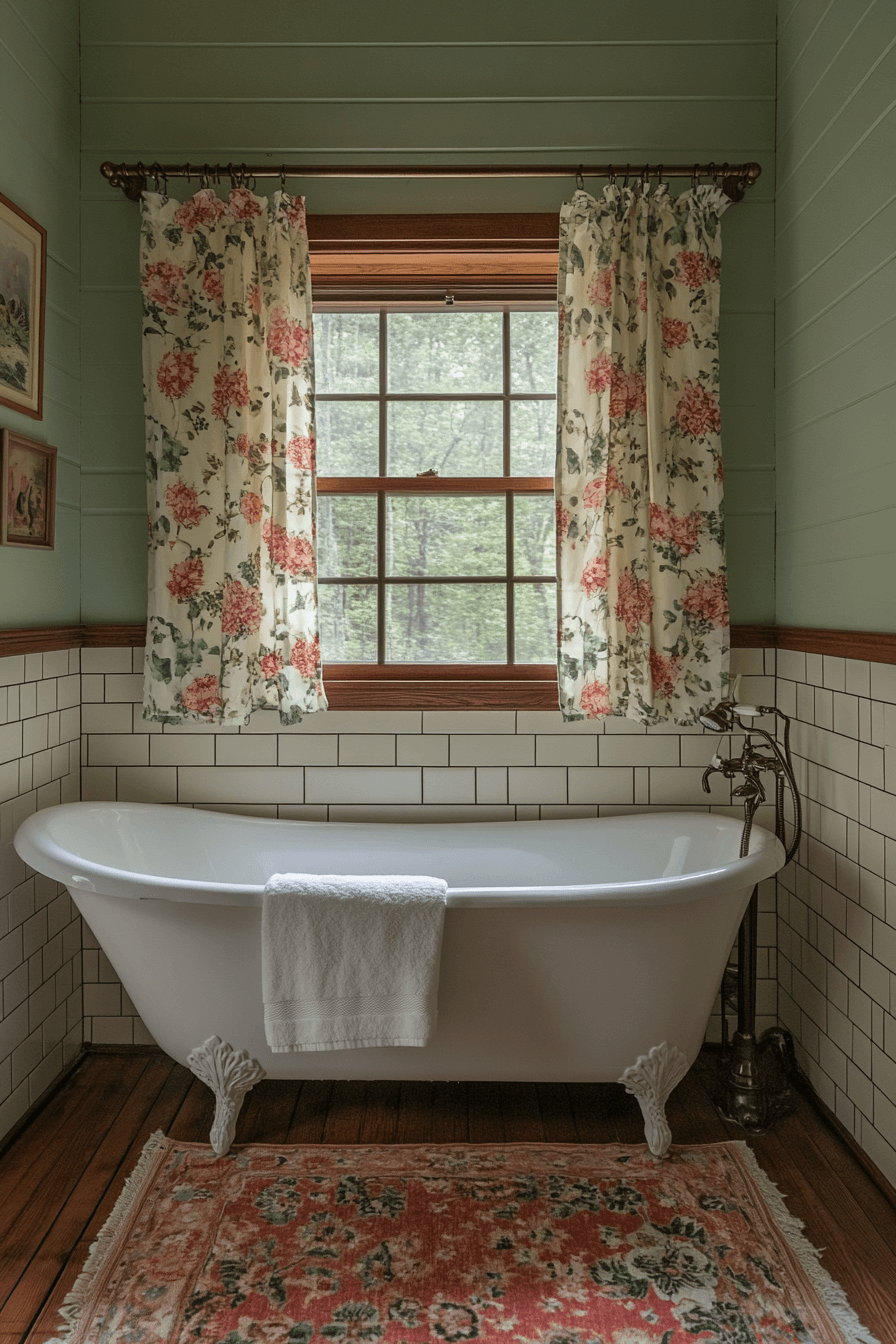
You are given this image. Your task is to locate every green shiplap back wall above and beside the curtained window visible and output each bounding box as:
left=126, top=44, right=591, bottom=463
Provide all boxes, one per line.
left=81, top=0, right=775, bottom=622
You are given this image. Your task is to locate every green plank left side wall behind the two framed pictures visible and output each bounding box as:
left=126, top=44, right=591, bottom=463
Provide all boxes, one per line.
left=0, top=0, right=81, bottom=629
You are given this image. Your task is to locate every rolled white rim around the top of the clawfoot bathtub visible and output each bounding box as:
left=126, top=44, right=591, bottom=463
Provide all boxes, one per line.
left=13, top=801, right=785, bottom=909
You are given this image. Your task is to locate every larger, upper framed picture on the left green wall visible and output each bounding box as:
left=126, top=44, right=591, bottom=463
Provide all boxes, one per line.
left=0, top=195, right=47, bottom=419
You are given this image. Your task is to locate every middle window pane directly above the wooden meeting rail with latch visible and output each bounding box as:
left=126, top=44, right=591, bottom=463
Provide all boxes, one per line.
left=387, top=402, right=504, bottom=476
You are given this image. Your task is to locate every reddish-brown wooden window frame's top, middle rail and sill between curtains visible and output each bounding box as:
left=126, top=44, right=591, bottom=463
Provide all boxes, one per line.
left=308, top=214, right=557, bottom=710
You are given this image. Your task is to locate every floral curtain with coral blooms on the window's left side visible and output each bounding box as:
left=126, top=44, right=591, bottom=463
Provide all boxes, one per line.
left=141, top=187, right=326, bottom=723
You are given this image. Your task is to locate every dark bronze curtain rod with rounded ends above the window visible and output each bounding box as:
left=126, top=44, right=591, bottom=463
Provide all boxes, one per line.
left=99, top=161, right=762, bottom=200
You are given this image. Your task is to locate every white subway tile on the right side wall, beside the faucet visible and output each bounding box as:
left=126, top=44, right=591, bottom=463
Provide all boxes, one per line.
left=776, top=650, right=896, bottom=1185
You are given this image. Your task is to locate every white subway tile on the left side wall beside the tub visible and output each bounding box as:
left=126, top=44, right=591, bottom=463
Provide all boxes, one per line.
left=0, top=649, right=83, bottom=1137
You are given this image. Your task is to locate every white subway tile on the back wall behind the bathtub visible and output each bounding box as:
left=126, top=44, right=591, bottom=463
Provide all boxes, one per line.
left=71, top=649, right=778, bottom=1059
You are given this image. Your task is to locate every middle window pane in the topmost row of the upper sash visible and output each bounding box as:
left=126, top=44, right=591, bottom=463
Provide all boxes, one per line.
left=387, top=310, right=502, bottom=392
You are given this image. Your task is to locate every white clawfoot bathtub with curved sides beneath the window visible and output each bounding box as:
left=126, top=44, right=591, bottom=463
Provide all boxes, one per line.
left=15, top=802, right=783, bottom=1150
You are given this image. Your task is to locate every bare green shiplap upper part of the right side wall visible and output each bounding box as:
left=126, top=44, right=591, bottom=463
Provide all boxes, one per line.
left=776, top=0, right=896, bottom=630
